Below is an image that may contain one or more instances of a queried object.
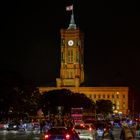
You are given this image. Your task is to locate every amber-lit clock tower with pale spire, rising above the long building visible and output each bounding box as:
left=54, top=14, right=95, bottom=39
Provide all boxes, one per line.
left=56, top=12, right=84, bottom=87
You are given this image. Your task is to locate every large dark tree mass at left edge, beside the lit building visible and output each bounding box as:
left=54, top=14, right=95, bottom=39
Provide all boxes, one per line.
left=0, top=71, right=41, bottom=116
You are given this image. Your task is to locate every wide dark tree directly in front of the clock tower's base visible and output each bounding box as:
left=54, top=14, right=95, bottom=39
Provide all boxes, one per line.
left=41, top=89, right=94, bottom=114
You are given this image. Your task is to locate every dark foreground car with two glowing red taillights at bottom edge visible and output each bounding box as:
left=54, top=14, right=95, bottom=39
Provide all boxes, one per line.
left=44, top=126, right=80, bottom=140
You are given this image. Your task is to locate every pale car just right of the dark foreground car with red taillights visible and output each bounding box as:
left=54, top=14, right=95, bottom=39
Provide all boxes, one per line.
left=74, top=125, right=95, bottom=140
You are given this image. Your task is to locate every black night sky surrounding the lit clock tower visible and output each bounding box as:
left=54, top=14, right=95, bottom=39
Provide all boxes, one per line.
left=0, top=0, right=140, bottom=90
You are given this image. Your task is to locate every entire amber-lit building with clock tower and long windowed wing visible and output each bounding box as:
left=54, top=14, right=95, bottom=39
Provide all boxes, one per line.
left=39, top=10, right=129, bottom=114
